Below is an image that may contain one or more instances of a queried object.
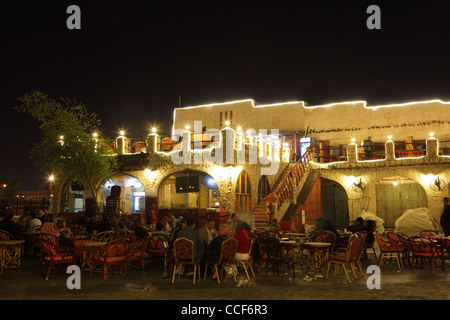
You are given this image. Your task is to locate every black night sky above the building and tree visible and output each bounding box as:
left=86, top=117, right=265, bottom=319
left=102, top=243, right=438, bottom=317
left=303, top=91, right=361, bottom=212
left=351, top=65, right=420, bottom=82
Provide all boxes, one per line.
left=0, top=0, right=450, bottom=189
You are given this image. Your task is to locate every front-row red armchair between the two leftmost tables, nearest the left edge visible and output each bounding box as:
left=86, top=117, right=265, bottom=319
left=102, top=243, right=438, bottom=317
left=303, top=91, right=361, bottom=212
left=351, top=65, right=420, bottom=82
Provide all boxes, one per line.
left=39, top=233, right=76, bottom=280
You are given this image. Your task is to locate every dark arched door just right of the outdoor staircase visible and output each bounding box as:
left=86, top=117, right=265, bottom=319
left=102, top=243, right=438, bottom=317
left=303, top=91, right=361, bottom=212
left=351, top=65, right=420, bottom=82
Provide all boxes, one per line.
left=321, top=178, right=349, bottom=227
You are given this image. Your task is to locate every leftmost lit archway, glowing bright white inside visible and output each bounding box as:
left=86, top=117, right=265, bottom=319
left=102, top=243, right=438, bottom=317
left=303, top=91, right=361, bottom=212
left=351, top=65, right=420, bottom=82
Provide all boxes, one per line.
left=100, top=173, right=145, bottom=216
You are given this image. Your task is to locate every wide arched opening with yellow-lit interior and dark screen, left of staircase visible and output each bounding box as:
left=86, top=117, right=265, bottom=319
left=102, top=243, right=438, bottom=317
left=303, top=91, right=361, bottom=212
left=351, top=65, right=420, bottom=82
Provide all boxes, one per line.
left=158, top=170, right=219, bottom=211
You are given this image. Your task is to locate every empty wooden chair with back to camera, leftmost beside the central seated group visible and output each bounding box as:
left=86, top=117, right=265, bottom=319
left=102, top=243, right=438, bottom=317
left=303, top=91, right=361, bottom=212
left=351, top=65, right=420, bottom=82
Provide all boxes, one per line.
left=172, top=237, right=200, bottom=284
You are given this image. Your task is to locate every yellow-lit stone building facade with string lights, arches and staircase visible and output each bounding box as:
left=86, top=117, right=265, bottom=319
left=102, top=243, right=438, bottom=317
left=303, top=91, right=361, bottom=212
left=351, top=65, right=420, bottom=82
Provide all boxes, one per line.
left=51, top=99, right=450, bottom=230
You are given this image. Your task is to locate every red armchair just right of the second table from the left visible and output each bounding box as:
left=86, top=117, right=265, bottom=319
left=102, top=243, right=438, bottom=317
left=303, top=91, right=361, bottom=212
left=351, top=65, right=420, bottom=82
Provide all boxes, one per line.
left=91, top=239, right=128, bottom=280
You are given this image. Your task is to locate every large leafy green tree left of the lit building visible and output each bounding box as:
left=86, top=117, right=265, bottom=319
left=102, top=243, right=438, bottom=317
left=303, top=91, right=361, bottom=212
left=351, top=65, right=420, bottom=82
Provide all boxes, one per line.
left=14, top=91, right=116, bottom=211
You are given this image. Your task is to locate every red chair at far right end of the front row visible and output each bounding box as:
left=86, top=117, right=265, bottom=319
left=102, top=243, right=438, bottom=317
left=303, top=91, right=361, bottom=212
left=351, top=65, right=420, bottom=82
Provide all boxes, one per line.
left=410, top=237, right=445, bottom=271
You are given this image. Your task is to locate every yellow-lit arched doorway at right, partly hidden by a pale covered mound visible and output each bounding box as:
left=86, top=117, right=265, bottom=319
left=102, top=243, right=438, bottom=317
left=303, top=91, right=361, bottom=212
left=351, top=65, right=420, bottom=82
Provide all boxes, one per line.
left=375, top=176, right=428, bottom=228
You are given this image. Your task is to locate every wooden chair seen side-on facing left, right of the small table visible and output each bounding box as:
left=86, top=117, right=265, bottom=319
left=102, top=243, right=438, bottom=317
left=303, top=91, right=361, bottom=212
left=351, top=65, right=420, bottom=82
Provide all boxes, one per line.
left=326, top=233, right=362, bottom=282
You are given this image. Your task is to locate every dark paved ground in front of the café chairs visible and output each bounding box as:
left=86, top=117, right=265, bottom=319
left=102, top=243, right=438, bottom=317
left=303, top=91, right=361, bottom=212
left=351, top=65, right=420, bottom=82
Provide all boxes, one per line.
left=0, top=252, right=450, bottom=301
